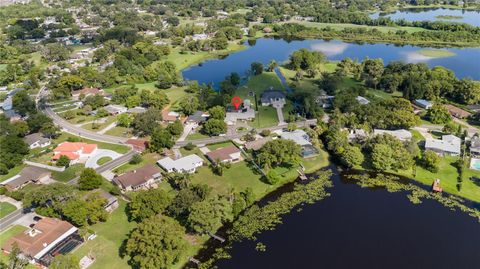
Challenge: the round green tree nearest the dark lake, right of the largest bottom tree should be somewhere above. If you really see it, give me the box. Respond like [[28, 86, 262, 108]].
[[188, 196, 229, 234]]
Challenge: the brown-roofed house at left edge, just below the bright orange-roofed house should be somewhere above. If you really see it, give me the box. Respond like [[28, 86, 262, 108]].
[[0, 166, 51, 191]]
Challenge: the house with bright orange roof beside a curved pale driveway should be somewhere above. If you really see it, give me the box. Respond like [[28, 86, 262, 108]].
[[52, 142, 97, 163]]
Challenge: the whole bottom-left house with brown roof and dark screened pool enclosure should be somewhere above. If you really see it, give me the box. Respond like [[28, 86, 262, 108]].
[[2, 217, 83, 267]]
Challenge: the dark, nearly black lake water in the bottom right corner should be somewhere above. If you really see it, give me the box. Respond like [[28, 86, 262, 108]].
[[217, 169, 480, 269]]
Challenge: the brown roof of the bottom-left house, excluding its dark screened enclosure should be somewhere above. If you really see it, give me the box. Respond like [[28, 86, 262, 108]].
[[2, 217, 74, 257]]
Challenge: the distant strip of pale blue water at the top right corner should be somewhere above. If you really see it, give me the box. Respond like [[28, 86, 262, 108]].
[[370, 8, 480, 26]]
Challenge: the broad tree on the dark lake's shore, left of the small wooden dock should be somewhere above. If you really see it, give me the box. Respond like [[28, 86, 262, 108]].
[[255, 139, 301, 168]]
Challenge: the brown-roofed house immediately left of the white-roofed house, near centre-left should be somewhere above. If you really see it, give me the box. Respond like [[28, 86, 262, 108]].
[[113, 164, 162, 191]]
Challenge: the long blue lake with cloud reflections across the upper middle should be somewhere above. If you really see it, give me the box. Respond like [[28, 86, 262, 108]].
[[182, 38, 480, 86]]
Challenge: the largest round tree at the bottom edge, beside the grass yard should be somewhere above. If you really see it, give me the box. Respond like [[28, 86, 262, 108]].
[[125, 215, 187, 269]]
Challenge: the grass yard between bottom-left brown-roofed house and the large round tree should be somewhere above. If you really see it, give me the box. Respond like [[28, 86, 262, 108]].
[[74, 200, 136, 269]]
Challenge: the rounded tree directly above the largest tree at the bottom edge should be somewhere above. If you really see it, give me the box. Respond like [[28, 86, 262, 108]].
[[128, 189, 172, 222]]
